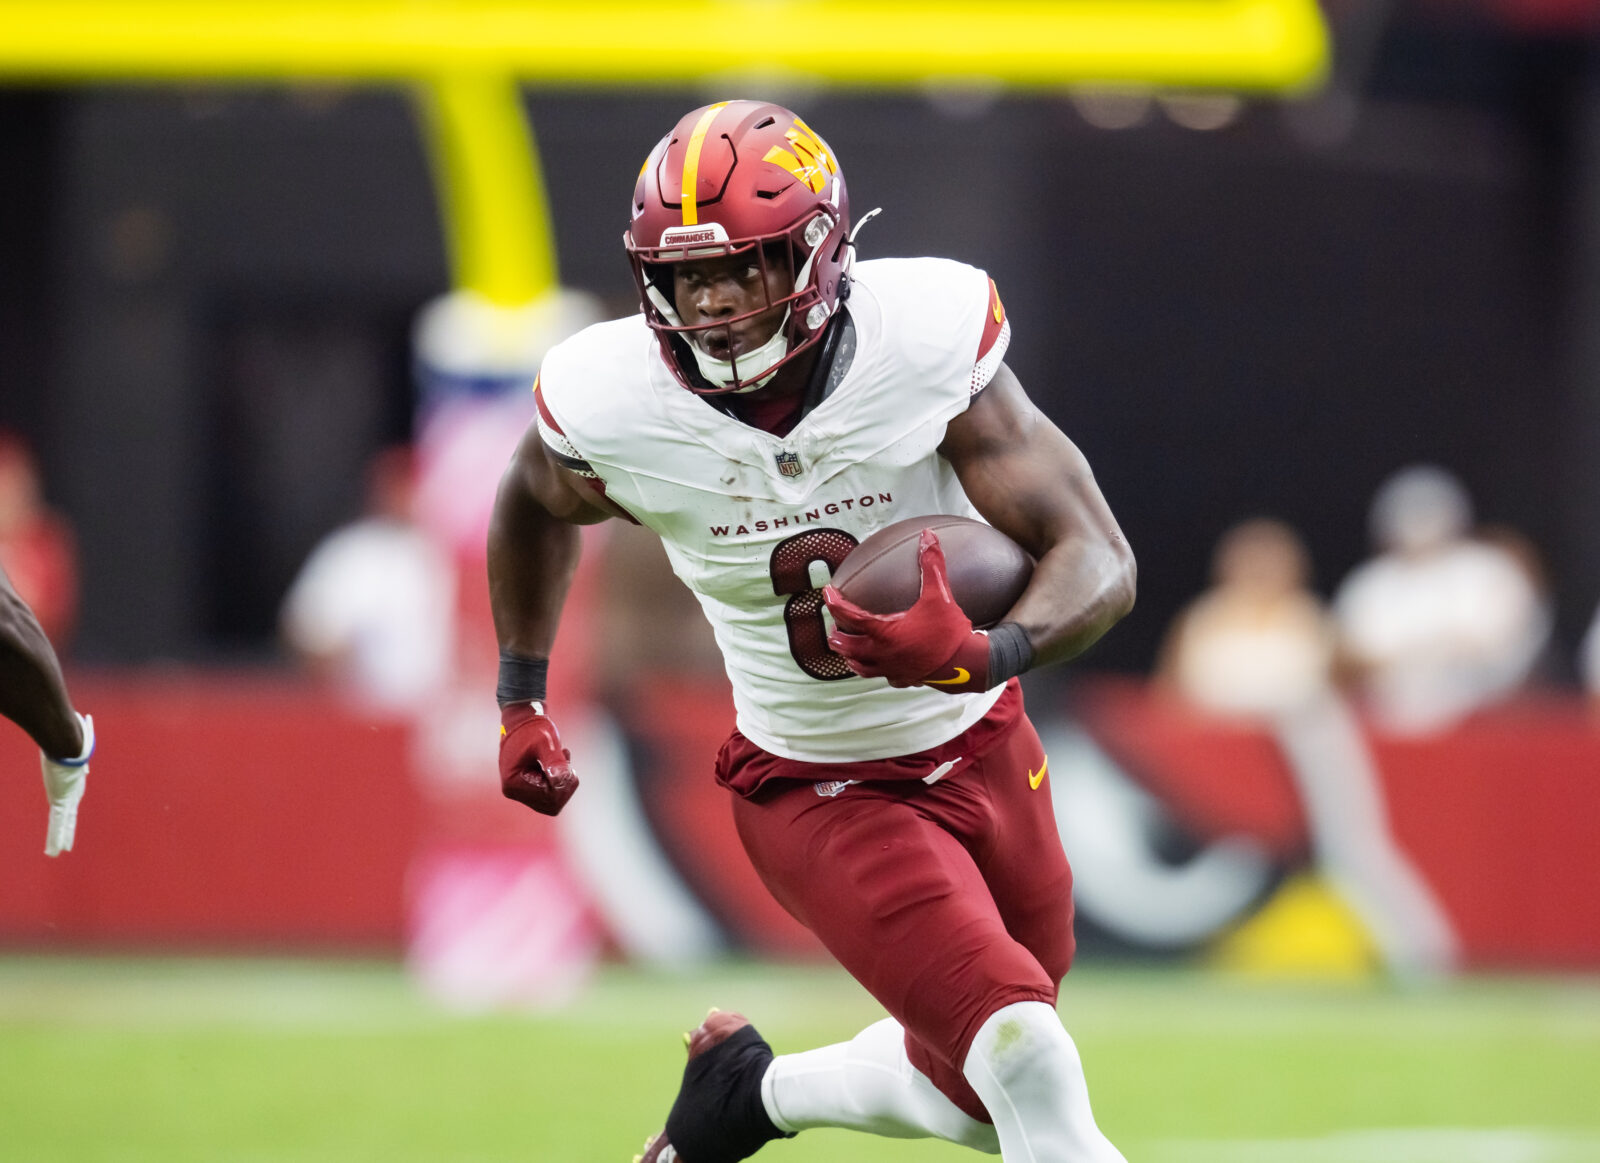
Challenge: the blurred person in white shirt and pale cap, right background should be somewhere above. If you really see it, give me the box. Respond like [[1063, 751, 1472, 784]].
[[1334, 466, 1550, 734]]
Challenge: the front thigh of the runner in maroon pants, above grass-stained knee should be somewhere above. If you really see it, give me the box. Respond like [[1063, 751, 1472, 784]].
[[734, 785, 1056, 1061]]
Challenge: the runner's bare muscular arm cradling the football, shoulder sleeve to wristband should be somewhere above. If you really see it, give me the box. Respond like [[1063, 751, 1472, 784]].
[[939, 363, 1136, 665]]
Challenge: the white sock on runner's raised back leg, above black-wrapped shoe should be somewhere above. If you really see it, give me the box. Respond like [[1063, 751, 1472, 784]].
[[762, 1017, 1000, 1155]]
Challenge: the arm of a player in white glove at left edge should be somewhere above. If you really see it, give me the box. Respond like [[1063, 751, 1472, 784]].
[[0, 570, 94, 856]]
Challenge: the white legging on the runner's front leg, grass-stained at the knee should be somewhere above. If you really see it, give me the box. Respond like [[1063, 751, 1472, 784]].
[[962, 1001, 1126, 1163]]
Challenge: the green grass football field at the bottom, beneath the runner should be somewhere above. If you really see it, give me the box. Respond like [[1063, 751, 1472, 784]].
[[0, 957, 1600, 1163]]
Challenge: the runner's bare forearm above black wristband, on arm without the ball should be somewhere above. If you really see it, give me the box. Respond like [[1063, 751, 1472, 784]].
[[488, 488, 592, 657]]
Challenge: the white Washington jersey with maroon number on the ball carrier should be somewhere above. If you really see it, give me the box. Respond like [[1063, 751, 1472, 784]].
[[539, 259, 1010, 763]]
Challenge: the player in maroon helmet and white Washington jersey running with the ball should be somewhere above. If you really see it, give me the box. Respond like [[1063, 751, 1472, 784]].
[[488, 101, 1134, 1163]]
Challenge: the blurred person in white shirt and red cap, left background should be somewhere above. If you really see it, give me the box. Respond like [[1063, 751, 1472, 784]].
[[280, 446, 456, 715]]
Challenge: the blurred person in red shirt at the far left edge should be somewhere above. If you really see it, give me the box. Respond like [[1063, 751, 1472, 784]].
[[0, 430, 78, 649]]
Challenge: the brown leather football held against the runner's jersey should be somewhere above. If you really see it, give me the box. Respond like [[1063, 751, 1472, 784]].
[[834, 515, 1034, 630]]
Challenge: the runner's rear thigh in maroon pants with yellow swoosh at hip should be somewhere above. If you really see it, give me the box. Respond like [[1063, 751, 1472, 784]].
[[976, 717, 1075, 982]]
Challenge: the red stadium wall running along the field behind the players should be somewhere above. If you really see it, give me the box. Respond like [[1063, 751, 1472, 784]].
[[0, 675, 1600, 968]]
